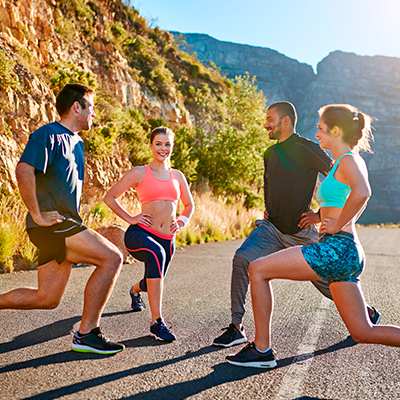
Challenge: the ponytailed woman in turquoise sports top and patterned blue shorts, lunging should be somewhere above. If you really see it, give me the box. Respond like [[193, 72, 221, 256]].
[[227, 104, 400, 368]]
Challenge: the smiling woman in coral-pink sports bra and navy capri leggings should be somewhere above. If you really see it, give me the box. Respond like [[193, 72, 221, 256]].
[[104, 127, 194, 342]]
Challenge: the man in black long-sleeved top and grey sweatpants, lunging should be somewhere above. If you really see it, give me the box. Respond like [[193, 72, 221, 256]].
[[213, 101, 380, 347]]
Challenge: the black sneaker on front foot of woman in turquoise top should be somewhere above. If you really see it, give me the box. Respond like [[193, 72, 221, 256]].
[[226, 343, 277, 369]]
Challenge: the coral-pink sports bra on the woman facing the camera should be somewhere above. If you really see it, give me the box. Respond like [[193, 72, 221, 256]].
[[136, 164, 181, 204]]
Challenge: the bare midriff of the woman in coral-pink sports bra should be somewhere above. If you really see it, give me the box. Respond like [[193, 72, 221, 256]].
[[142, 200, 176, 235]]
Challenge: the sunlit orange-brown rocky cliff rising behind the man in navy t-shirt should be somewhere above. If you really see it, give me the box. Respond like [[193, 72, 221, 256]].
[[0, 0, 185, 201]]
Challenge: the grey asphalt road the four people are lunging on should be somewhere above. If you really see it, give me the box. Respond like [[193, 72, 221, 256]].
[[0, 229, 400, 400]]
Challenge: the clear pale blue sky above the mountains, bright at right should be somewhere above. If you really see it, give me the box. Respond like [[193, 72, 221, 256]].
[[130, 0, 400, 69]]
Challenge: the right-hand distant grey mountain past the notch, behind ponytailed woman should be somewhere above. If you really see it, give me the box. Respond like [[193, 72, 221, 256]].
[[299, 51, 400, 223]]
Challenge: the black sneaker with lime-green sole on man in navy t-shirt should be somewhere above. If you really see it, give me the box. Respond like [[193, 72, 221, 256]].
[[71, 327, 125, 354]]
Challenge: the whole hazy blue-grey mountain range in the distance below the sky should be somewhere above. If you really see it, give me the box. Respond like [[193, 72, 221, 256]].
[[178, 34, 400, 224]]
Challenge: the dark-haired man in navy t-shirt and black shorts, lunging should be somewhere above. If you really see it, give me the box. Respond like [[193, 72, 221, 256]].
[[0, 84, 124, 354]]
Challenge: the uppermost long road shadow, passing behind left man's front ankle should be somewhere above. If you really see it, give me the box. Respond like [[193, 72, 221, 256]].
[[0, 311, 132, 354]]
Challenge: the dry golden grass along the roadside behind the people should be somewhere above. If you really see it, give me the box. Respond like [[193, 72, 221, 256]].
[[0, 192, 262, 273]]
